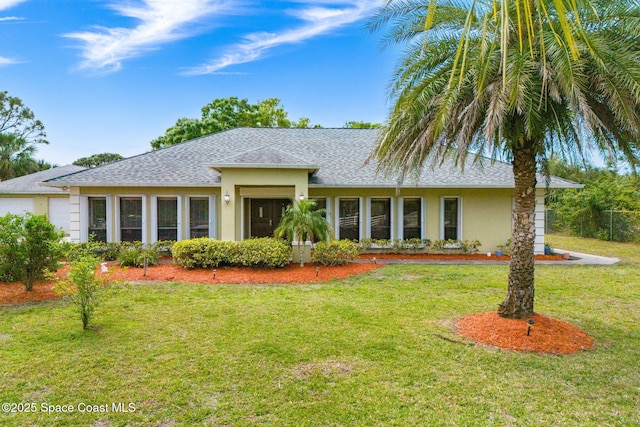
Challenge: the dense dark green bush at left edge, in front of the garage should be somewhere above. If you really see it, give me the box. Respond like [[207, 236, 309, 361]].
[[0, 214, 64, 291]]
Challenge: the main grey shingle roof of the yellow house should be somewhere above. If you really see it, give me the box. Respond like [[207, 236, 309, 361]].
[[42, 128, 579, 188]]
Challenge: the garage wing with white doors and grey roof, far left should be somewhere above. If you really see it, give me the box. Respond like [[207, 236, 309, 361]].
[[0, 165, 85, 233]]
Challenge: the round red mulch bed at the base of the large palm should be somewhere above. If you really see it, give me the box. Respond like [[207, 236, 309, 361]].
[[457, 312, 593, 354]]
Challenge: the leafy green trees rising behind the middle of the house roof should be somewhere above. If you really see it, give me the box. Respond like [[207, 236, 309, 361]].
[[151, 97, 316, 150]]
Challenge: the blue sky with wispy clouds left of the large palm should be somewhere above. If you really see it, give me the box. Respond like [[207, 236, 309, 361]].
[[0, 0, 397, 165]]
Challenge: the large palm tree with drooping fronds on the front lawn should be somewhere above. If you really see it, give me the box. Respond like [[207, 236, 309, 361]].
[[371, 0, 640, 318]]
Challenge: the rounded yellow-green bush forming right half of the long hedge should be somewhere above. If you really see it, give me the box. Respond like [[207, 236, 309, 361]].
[[237, 237, 291, 268]]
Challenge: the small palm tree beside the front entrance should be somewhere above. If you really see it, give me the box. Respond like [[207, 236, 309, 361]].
[[274, 199, 331, 267]]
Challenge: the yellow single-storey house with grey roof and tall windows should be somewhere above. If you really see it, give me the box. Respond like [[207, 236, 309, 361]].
[[41, 128, 579, 252]]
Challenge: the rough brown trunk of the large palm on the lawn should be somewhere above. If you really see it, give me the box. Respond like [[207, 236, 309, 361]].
[[498, 146, 536, 319]]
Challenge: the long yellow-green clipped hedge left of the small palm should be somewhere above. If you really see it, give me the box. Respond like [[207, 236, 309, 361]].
[[172, 237, 291, 269]]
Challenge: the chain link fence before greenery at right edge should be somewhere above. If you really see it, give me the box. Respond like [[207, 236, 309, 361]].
[[545, 209, 640, 243]]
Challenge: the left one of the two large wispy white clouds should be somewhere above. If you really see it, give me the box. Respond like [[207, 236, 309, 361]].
[[63, 0, 237, 72]]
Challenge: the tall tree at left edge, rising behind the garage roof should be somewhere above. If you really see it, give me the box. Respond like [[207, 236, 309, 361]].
[[0, 92, 50, 181]]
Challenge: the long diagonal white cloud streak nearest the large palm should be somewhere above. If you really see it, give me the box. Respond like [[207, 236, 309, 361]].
[[186, 0, 382, 75]]
